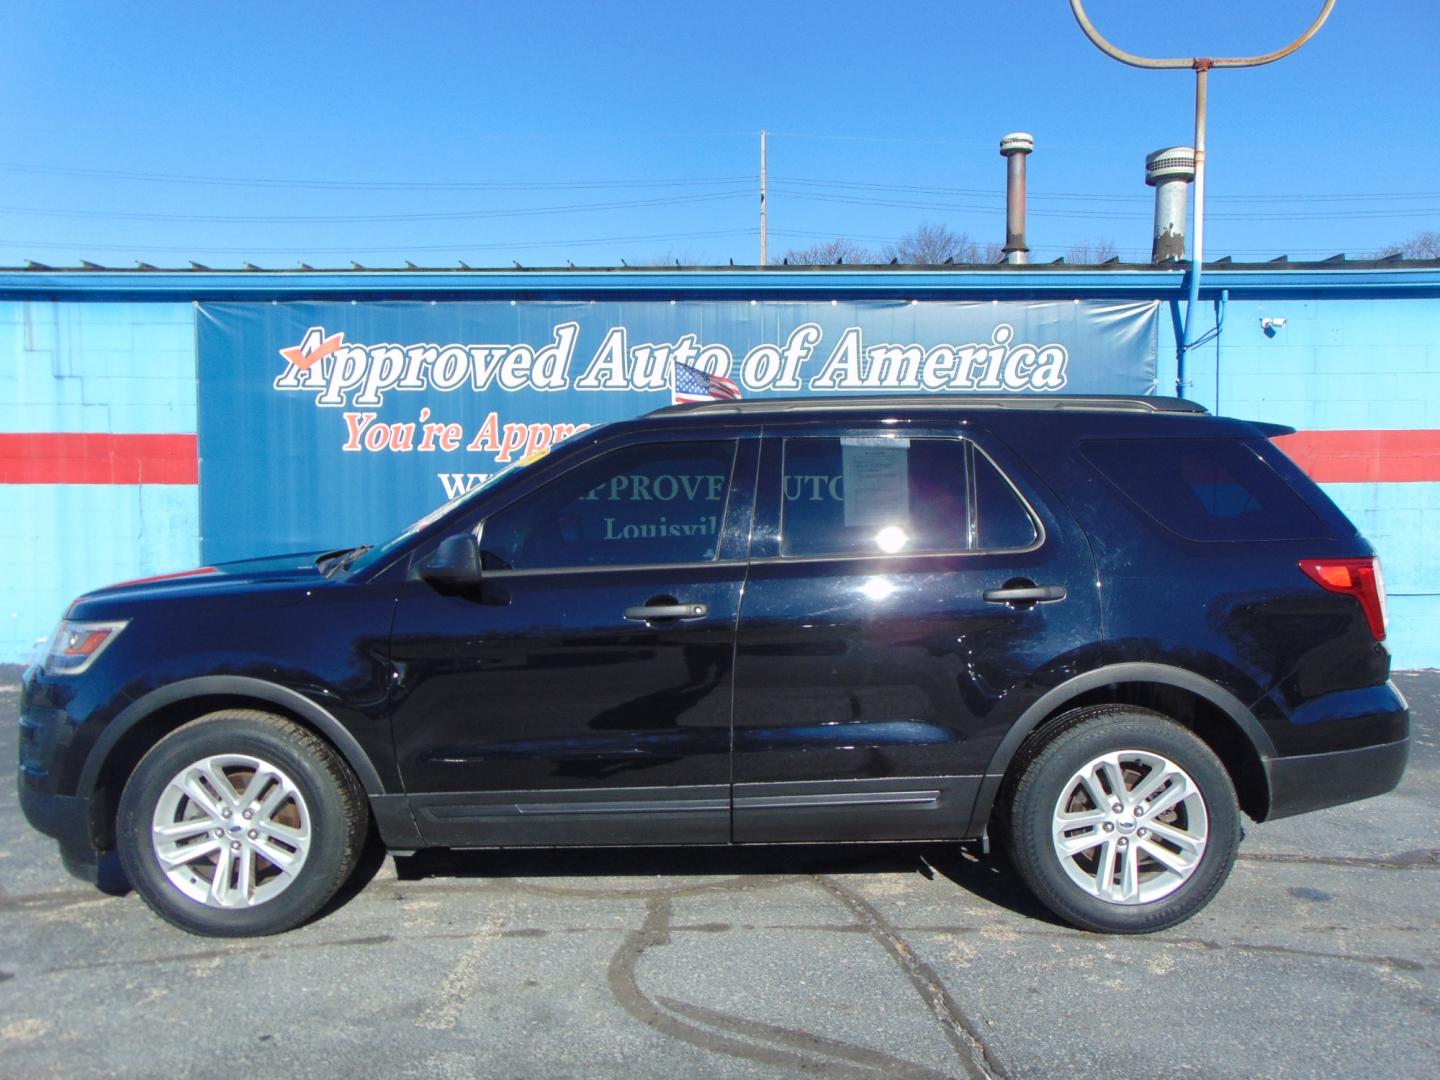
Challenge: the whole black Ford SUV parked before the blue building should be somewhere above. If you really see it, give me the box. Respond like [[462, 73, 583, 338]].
[[20, 396, 1410, 935]]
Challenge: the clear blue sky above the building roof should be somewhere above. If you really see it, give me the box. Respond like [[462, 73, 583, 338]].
[[0, 0, 1440, 266]]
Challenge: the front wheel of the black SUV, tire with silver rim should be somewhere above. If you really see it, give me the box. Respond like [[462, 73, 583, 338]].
[[115, 708, 369, 937]]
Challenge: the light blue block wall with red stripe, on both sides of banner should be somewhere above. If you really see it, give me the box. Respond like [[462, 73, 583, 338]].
[[0, 297, 1440, 667]]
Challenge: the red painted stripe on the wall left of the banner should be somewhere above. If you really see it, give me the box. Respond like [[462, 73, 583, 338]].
[[0, 432, 200, 484]]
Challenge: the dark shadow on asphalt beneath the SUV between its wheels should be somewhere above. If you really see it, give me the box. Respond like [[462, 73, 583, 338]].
[[383, 842, 1063, 926]]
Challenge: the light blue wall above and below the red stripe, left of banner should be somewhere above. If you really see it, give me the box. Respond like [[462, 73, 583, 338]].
[[0, 300, 200, 662]]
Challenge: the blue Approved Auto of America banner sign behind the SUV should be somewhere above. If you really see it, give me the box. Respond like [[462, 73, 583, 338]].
[[197, 300, 1159, 562]]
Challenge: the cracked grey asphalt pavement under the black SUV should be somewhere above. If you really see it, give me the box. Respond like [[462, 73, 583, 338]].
[[0, 670, 1440, 1080]]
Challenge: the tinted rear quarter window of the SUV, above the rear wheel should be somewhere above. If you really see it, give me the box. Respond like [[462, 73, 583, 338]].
[[1081, 439, 1331, 541]]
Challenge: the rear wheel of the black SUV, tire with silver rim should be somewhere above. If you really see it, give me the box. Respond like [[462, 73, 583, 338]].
[[1008, 706, 1240, 933]]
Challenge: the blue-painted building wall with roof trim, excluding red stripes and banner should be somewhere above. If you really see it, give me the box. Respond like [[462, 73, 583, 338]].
[[0, 268, 1440, 667]]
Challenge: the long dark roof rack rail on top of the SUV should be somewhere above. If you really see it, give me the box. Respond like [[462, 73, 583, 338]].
[[645, 393, 1210, 416]]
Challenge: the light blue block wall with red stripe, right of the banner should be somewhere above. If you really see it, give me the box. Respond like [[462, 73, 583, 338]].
[[1159, 297, 1440, 668]]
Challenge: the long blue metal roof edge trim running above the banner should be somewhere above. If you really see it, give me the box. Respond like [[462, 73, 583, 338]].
[[0, 258, 1440, 301]]
